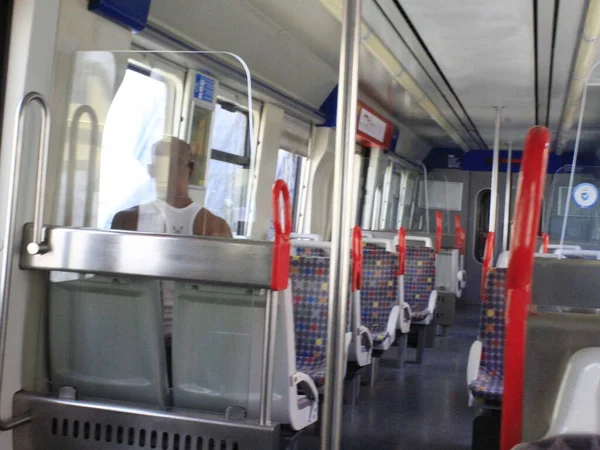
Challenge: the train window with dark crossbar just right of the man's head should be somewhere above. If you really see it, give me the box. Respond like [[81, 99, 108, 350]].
[[205, 102, 251, 235]]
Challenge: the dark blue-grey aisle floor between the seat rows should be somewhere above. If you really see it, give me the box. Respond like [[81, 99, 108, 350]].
[[299, 305, 479, 450]]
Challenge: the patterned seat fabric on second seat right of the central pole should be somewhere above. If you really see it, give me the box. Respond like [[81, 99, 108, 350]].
[[404, 247, 435, 323]]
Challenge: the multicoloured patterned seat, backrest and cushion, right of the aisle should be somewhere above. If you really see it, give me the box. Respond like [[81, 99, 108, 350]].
[[469, 268, 507, 407]]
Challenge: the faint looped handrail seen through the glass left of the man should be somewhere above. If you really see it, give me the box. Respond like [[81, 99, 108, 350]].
[[65, 105, 98, 227]]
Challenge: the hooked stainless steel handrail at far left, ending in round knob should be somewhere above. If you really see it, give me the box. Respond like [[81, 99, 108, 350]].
[[23, 92, 50, 255]]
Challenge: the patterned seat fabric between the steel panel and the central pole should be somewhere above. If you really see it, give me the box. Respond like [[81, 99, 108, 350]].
[[290, 256, 329, 386]]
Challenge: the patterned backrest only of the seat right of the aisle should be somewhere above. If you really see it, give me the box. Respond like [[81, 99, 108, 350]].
[[479, 268, 508, 376]]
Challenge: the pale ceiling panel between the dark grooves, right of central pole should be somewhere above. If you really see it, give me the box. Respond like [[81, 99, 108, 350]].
[[400, 0, 535, 147]]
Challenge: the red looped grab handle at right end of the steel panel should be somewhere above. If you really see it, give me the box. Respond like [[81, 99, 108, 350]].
[[271, 180, 292, 291]]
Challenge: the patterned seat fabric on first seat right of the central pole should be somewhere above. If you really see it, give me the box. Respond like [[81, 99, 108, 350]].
[[360, 248, 398, 348]]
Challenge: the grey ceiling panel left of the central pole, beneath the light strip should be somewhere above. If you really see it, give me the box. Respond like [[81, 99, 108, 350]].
[[150, 0, 340, 107]]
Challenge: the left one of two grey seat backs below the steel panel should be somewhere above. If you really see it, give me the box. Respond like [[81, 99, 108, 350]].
[[49, 277, 168, 406]]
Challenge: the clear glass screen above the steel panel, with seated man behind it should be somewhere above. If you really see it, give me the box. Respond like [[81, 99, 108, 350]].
[[51, 52, 254, 237]]
